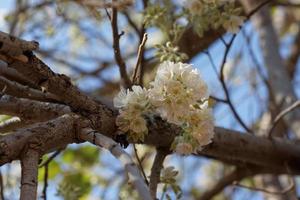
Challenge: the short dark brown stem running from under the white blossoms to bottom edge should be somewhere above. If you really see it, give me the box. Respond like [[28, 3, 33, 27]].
[[149, 148, 169, 199]]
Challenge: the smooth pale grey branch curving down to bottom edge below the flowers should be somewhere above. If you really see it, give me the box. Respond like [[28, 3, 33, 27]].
[[80, 128, 152, 200]]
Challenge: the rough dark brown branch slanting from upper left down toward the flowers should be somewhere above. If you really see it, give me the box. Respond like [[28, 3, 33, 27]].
[[9, 55, 116, 134]]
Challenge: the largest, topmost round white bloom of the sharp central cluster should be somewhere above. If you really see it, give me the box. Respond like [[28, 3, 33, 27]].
[[149, 62, 208, 125]]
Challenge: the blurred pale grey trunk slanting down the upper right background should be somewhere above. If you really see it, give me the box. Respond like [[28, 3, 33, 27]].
[[241, 0, 300, 136]]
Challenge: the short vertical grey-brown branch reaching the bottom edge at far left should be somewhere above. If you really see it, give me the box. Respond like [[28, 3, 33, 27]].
[[20, 148, 39, 200]]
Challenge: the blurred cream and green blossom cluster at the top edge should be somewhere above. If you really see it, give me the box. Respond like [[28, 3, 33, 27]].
[[186, 0, 245, 36]]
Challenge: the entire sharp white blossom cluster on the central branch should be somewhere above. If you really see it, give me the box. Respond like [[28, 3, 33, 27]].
[[114, 61, 214, 154]]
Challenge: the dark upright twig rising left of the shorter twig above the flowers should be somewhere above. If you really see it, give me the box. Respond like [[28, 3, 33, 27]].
[[111, 2, 131, 88]]
